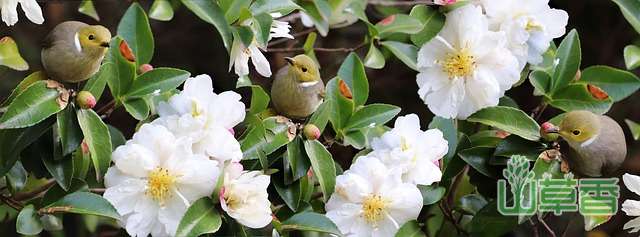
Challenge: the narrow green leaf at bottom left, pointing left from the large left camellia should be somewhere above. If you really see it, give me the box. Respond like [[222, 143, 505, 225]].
[[45, 192, 120, 220]]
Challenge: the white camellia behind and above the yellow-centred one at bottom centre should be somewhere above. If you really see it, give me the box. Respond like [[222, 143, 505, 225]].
[[371, 114, 449, 185]]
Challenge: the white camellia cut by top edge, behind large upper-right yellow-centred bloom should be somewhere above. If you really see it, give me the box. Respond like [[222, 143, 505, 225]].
[[479, 0, 569, 68]]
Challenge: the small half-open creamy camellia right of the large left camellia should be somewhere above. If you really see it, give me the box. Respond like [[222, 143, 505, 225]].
[[220, 163, 272, 228]]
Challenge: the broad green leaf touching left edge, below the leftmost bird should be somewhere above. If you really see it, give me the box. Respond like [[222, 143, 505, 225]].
[[0, 81, 68, 129]]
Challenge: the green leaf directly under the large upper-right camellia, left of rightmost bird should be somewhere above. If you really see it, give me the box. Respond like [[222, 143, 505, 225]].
[[467, 106, 540, 141]]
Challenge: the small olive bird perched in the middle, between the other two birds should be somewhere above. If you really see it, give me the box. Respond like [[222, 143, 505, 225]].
[[271, 54, 324, 119]]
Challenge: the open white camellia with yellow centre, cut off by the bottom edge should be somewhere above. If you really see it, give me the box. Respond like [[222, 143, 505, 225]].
[[325, 155, 422, 237]]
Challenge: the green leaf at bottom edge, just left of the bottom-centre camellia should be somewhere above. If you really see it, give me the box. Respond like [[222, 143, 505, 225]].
[[281, 212, 342, 236]]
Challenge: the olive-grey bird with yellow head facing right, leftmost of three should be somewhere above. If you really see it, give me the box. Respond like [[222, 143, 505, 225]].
[[41, 21, 111, 83]]
